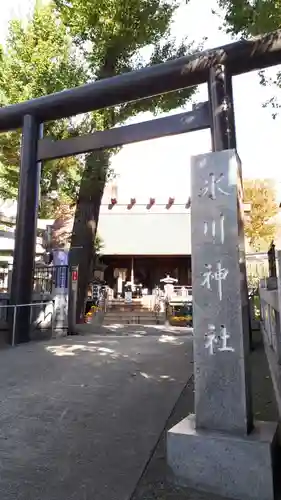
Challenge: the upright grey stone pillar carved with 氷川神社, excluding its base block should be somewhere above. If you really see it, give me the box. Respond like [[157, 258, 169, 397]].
[[191, 150, 252, 433]]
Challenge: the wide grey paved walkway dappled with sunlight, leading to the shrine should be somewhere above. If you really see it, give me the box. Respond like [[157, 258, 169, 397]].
[[0, 331, 193, 500]]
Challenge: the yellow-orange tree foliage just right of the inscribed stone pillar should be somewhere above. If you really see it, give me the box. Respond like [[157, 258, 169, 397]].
[[244, 179, 278, 251]]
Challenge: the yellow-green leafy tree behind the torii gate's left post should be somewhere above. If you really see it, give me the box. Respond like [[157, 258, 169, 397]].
[[0, 3, 87, 213]]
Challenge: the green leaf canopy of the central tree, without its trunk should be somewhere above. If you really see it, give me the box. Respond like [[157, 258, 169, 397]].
[[54, 0, 197, 124]]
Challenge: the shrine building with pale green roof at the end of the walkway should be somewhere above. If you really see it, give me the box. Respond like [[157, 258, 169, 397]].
[[98, 182, 191, 294]]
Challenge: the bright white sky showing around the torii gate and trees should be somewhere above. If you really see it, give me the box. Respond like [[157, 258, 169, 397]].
[[0, 0, 281, 201]]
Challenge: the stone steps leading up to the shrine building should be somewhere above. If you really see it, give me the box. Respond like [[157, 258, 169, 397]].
[[103, 299, 165, 326]]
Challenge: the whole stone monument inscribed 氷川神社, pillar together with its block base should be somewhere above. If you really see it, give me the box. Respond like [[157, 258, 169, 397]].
[[167, 150, 277, 500]]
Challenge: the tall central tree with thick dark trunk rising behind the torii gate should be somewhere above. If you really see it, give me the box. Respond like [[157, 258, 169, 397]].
[[55, 0, 196, 315]]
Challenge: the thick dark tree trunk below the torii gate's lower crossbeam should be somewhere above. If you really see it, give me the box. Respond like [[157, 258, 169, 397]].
[[71, 151, 107, 322]]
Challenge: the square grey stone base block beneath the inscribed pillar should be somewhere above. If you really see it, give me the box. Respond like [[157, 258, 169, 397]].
[[167, 415, 278, 500]]
